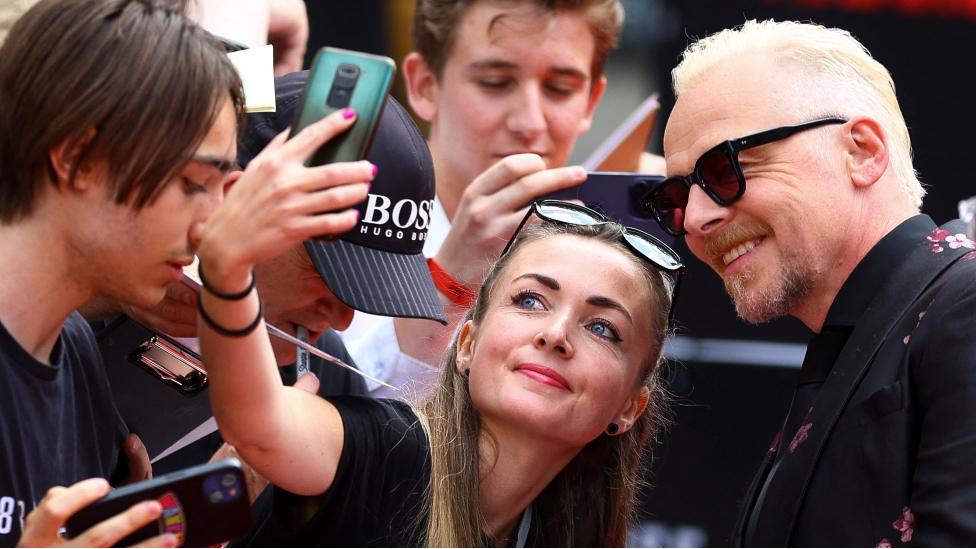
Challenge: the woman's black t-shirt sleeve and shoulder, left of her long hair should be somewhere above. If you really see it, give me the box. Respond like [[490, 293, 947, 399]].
[[241, 397, 430, 547]]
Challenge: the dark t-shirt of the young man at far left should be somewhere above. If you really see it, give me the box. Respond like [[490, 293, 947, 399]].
[[0, 313, 127, 547]]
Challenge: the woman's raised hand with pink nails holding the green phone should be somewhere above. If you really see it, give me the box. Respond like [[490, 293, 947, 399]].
[[199, 109, 376, 291]]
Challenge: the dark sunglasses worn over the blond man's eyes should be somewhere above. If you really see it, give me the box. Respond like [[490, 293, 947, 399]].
[[640, 116, 847, 236]]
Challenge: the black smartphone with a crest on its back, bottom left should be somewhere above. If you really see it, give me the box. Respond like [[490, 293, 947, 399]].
[[65, 459, 251, 547]]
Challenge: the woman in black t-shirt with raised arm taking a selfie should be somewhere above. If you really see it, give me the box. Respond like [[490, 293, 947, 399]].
[[200, 149, 682, 547]]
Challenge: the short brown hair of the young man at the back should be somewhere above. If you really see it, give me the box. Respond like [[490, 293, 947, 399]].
[[413, 0, 624, 81]]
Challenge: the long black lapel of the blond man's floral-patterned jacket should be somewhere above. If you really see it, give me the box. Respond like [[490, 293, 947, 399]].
[[753, 221, 971, 547]]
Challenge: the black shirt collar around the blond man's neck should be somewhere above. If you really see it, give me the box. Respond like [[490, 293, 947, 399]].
[[824, 214, 936, 328]]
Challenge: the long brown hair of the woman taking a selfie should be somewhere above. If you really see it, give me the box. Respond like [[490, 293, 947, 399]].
[[418, 223, 673, 547]]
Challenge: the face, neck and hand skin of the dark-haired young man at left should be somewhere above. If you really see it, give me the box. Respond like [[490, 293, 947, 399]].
[[0, 100, 237, 546]]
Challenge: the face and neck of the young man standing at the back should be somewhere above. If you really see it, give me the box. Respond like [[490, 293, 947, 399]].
[[406, 2, 606, 217]]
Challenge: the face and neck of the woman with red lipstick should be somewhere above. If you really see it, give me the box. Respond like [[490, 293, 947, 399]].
[[458, 235, 653, 540]]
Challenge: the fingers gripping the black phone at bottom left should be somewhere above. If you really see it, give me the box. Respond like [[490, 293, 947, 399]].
[[17, 478, 177, 547]]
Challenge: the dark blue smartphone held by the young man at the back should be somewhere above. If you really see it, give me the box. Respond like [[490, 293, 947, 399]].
[[536, 172, 674, 243]]
